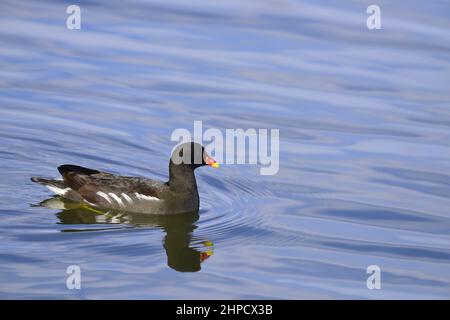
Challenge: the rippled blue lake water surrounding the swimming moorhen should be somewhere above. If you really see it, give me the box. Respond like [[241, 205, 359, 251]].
[[0, 0, 450, 299]]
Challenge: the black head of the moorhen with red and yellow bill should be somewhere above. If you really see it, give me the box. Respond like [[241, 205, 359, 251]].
[[170, 142, 219, 170]]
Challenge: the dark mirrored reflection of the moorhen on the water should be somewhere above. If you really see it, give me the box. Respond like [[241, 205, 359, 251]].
[[40, 197, 213, 272]]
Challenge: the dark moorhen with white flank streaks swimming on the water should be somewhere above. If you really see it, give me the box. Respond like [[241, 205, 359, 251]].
[[31, 142, 219, 214]]
